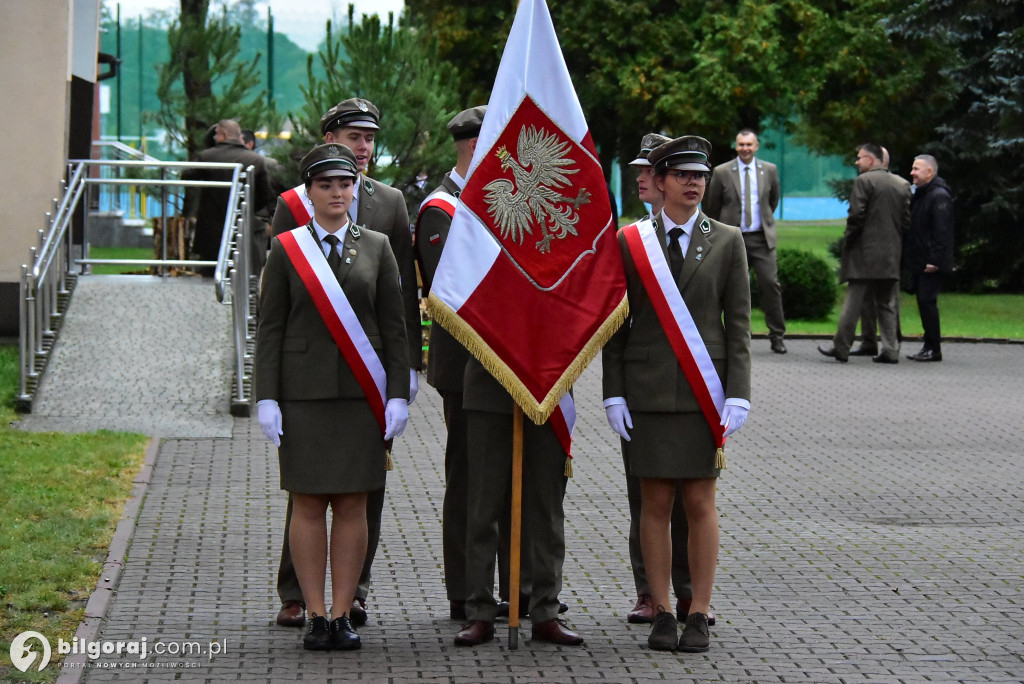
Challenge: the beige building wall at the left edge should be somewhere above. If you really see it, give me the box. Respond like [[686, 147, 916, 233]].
[[0, 0, 99, 337]]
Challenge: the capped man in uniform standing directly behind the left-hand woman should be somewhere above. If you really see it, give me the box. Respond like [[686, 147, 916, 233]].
[[271, 97, 423, 627]]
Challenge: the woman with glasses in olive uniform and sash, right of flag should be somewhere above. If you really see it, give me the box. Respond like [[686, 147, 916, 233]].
[[602, 135, 751, 651]]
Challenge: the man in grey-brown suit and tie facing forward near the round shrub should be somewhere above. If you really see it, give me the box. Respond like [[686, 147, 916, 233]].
[[702, 128, 785, 354]]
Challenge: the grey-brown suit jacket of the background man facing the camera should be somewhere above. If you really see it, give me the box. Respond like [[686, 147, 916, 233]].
[[700, 157, 779, 249]]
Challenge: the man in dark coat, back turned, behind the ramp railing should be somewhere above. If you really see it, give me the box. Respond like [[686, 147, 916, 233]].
[[181, 119, 272, 275]]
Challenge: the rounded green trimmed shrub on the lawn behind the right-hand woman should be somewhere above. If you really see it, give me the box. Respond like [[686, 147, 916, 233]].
[[751, 250, 839, 320]]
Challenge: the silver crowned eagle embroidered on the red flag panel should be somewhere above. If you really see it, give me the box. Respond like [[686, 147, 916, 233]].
[[483, 125, 590, 254]]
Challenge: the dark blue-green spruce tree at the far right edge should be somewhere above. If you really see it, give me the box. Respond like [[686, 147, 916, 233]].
[[890, 0, 1024, 292]]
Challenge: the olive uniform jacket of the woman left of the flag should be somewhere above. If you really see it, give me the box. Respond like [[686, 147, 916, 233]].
[[255, 224, 409, 401]]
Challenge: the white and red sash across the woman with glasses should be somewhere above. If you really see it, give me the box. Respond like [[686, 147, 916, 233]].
[[623, 219, 725, 448]]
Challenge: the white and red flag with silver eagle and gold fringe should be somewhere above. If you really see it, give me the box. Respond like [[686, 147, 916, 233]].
[[429, 0, 628, 428]]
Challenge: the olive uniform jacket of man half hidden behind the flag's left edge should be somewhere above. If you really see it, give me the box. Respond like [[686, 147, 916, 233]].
[[416, 173, 470, 392]]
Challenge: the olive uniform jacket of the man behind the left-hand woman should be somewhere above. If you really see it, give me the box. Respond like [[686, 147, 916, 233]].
[[271, 174, 423, 369]]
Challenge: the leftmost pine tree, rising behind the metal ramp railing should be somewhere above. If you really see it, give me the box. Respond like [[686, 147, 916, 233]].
[[154, 0, 281, 159]]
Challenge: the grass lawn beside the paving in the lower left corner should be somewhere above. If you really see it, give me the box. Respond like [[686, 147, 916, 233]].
[[0, 346, 147, 682]]
